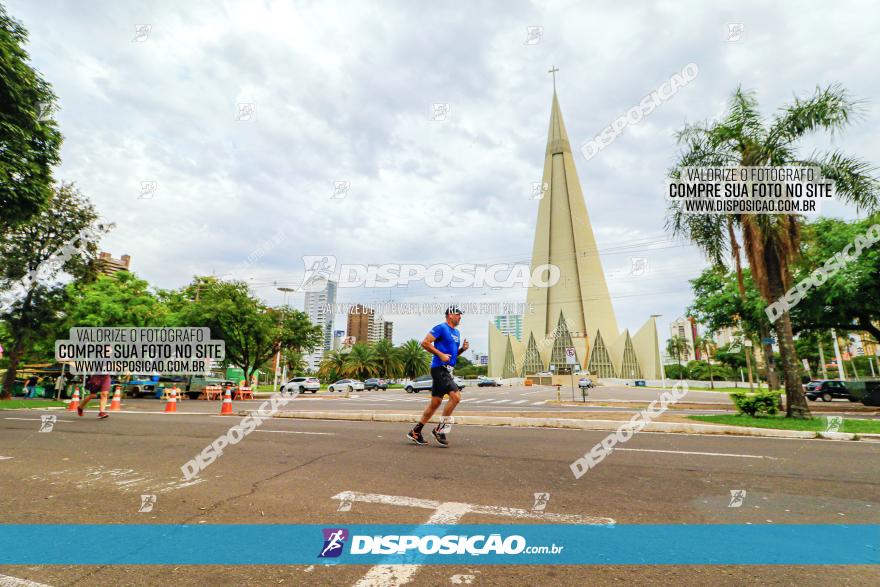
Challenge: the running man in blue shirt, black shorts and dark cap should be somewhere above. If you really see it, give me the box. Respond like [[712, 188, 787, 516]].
[[406, 306, 470, 446]]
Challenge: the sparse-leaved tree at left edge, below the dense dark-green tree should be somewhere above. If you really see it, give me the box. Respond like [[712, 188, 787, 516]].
[[0, 184, 107, 397]]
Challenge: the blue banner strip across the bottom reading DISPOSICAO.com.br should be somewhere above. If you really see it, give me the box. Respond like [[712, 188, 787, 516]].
[[0, 524, 880, 565]]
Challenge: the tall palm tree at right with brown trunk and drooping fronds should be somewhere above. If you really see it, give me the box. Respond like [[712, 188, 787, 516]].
[[667, 85, 880, 418]]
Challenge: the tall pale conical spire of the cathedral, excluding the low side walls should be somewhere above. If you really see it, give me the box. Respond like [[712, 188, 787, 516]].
[[523, 91, 619, 365]]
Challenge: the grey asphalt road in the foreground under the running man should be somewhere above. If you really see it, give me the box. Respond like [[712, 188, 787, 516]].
[[0, 406, 880, 586]]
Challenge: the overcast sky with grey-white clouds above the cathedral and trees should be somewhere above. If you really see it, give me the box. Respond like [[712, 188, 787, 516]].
[[6, 0, 880, 351]]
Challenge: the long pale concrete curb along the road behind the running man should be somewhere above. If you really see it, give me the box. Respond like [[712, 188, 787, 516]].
[[239, 410, 868, 440]]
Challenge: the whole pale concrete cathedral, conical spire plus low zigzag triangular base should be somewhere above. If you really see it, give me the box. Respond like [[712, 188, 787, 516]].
[[488, 89, 662, 380]]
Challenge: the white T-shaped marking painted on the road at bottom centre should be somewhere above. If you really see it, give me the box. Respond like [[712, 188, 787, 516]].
[[331, 491, 615, 587]]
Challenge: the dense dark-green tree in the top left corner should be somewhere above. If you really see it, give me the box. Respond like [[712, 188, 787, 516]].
[[0, 4, 62, 230]]
